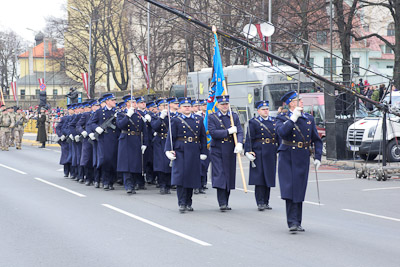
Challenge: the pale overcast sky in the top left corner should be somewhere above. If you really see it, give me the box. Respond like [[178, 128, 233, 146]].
[[0, 0, 67, 42]]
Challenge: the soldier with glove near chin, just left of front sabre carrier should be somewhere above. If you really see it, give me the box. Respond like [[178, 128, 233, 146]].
[[151, 99, 171, 195]]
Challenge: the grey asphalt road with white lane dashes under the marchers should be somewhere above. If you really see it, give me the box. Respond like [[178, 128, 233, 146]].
[[0, 146, 400, 267]]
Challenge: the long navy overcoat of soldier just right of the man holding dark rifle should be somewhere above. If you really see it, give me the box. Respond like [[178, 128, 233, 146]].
[[117, 111, 149, 173]]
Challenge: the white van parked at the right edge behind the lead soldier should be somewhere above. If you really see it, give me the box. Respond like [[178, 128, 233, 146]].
[[346, 91, 400, 161]]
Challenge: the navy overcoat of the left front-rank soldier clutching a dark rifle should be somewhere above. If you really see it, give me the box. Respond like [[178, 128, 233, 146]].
[[91, 106, 120, 171]]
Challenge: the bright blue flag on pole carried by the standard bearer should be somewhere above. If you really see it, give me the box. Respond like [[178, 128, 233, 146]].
[[204, 33, 227, 147]]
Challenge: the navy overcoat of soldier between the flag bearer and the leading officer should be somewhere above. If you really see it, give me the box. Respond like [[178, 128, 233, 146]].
[[244, 116, 278, 187]]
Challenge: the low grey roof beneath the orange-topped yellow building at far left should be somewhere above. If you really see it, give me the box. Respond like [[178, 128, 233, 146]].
[[17, 72, 82, 87]]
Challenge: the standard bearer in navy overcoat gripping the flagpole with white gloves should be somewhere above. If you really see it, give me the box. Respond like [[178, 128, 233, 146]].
[[208, 95, 243, 211]]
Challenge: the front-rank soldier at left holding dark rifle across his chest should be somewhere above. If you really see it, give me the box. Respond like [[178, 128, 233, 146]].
[[91, 93, 120, 191]]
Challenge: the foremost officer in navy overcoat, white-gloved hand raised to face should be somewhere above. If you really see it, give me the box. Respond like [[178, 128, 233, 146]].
[[276, 91, 322, 233]]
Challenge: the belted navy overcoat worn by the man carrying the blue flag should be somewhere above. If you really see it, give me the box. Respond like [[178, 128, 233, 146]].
[[208, 111, 243, 190]]
